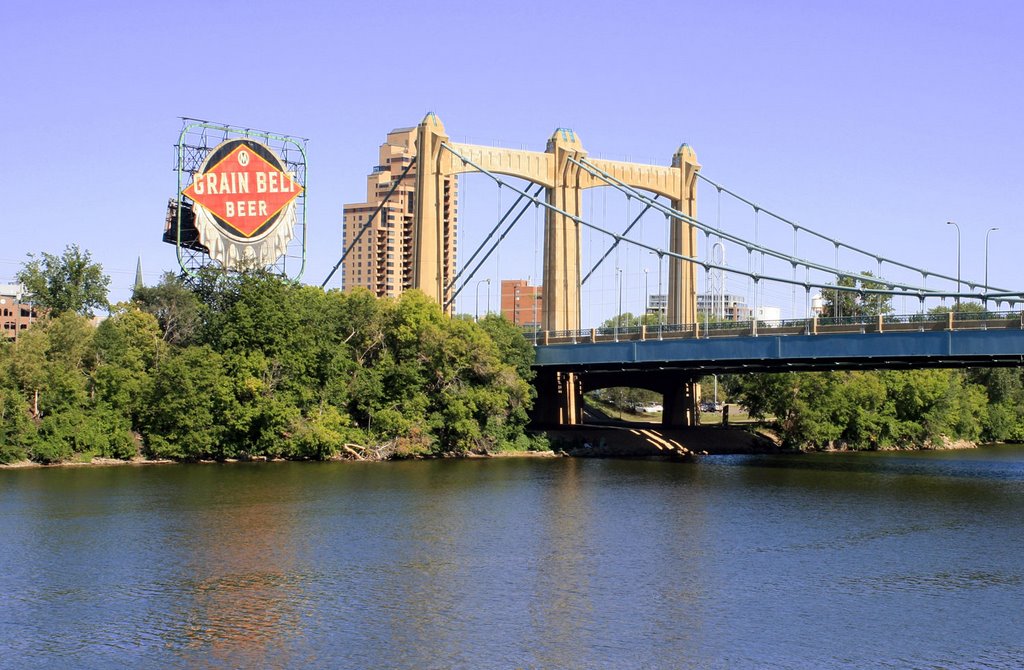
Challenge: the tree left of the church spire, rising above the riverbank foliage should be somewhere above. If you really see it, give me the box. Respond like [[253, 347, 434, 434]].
[[17, 244, 111, 317]]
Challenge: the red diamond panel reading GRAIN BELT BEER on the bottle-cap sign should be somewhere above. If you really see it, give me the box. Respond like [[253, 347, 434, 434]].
[[181, 139, 302, 239]]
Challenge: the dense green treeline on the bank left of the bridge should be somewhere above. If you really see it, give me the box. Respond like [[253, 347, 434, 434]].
[[0, 270, 538, 463]]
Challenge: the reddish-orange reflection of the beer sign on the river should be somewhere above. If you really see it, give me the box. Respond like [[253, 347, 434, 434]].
[[164, 475, 304, 667]]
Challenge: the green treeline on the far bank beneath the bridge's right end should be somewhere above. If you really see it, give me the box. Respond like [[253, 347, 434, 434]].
[[722, 368, 1024, 449]]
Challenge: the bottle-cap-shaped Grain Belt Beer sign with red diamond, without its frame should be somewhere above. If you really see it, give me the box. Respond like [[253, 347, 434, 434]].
[[181, 139, 302, 269]]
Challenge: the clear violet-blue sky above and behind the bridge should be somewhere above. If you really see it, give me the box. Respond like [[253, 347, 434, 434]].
[[0, 0, 1024, 325]]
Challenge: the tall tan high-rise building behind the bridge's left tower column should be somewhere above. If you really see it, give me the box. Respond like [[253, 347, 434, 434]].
[[341, 128, 458, 297]]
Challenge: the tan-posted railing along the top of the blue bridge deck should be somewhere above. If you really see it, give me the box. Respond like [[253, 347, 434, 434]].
[[524, 311, 1024, 345]]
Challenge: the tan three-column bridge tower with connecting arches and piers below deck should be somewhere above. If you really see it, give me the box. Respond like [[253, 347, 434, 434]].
[[412, 113, 700, 425]]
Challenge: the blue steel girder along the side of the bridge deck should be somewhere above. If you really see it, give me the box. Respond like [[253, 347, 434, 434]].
[[535, 322, 1024, 375]]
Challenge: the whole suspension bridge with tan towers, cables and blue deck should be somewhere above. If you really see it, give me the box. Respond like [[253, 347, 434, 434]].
[[324, 114, 1024, 426]]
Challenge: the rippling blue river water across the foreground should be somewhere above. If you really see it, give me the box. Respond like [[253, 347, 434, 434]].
[[0, 447, 1024, 668]]
